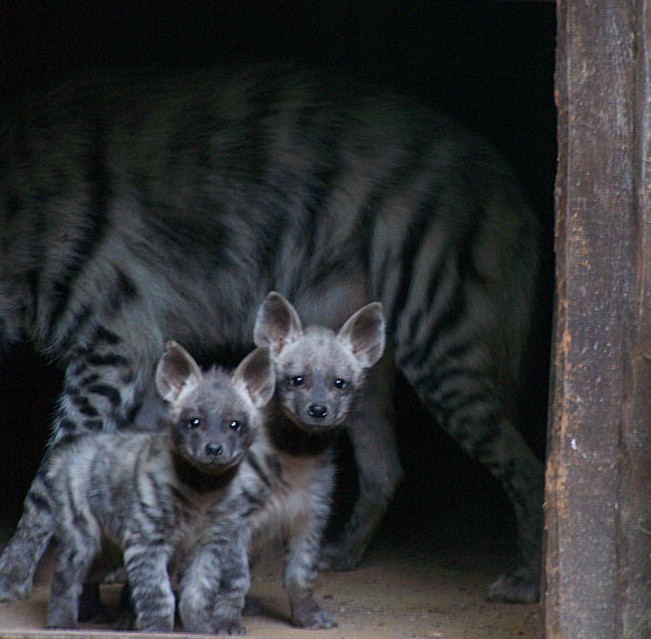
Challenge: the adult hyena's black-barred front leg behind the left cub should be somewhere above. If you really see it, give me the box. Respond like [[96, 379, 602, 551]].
[[0, 327, 162, 601]]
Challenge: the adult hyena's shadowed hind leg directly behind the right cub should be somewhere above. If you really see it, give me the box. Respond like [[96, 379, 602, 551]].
[[319, 353, 403, 570]]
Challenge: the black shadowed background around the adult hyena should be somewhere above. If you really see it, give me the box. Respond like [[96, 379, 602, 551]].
[[0, 0, 556, 556]]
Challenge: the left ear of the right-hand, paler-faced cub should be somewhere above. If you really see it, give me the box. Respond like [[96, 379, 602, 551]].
[[253, 291, 303, 355]]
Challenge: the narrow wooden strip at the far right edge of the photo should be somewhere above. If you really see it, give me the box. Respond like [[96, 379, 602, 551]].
[[619, 0, 651, 637]]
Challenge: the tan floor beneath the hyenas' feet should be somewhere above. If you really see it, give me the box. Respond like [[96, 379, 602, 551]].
[[0, 535, 542, 639]]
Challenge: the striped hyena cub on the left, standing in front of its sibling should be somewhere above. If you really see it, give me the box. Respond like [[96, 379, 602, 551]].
[[47, 342, 275, 634]]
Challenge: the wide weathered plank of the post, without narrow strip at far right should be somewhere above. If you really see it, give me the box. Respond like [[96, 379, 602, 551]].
[[544, 0, 641, 639]]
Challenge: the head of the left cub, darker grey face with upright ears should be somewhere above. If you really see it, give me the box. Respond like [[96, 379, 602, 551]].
[[156, 341, 275, 475]]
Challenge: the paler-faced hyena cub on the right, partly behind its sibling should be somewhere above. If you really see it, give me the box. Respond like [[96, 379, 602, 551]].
[[251, 292, 385, 628]]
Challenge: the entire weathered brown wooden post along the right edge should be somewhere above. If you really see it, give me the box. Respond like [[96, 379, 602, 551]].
[[544, 0, 651, 639]]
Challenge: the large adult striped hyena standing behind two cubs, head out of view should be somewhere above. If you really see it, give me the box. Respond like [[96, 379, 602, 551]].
[[0, 66, 543, 601]]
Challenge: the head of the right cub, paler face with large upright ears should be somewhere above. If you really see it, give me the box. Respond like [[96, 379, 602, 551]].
[[254, 292, 385, 431]]
